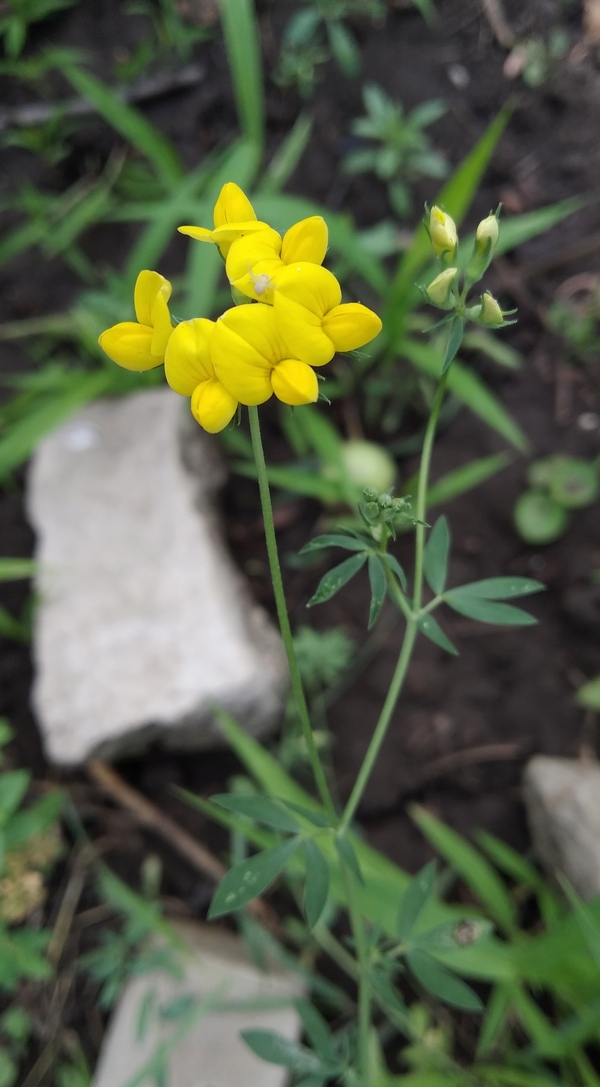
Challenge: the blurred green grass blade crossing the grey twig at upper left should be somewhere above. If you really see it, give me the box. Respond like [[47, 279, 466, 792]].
[[62, 64, 183, 187]]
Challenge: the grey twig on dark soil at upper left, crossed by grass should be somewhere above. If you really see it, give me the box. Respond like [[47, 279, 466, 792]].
[[0, 64, 204, 132]]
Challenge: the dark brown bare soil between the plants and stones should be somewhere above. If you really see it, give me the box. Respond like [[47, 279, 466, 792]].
[[0, 0, 600, 1069]]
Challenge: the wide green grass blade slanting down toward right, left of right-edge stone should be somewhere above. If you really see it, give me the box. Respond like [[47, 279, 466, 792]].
[[409, 804, 516, 932]]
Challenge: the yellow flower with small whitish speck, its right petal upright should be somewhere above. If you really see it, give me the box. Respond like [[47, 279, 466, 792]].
[[225, 215, 328, 303]]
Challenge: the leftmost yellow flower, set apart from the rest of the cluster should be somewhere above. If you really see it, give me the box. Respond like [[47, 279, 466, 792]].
[[98, 271, 173, 371]]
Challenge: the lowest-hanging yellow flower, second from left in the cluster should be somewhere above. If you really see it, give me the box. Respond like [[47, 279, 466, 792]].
[[164, 317, 237, 434]]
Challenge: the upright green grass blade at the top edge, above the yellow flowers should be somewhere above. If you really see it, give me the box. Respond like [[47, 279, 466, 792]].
[[218, 0, 264, 150]]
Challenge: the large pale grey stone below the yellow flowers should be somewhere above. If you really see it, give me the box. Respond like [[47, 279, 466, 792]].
[[27, 389, 287, 764]]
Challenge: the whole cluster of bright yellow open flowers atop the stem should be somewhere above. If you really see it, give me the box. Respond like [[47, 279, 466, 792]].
[[99, 182, 382, 434]]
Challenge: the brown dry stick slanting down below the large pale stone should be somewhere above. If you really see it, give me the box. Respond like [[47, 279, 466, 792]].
[[86, 759, 279, 933]]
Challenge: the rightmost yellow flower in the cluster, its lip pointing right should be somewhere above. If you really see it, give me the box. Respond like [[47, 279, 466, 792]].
[[273, 262, 382, 366]]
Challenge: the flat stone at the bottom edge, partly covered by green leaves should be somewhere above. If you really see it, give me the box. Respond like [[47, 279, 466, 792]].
[[93, 923, 302, 1087]]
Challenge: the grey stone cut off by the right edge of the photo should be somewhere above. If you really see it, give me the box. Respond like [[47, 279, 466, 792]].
[[523, 754, 600, 899]]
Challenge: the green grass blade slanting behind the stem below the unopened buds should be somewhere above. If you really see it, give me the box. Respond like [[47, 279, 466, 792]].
[[401, 339, 529, 453]]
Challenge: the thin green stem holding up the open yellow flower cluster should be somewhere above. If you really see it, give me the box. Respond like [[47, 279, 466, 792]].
[[248, 408, 336, 822]]
